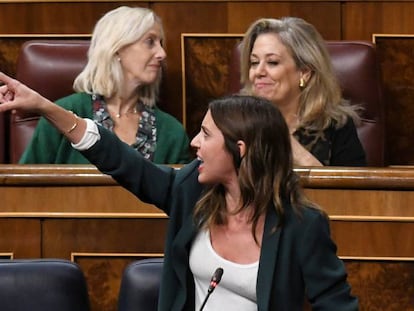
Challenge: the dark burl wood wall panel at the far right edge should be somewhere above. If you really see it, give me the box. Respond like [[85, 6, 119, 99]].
[[374, 34, 414, 165]]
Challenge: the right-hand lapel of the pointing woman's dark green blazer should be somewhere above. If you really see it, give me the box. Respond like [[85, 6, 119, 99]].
[[256, 208, 281, 311]]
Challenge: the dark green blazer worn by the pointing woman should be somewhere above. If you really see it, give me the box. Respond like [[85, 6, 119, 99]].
[[83, 127, 358, 311]]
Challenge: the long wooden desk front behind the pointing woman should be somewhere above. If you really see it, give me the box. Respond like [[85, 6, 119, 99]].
[[0, 165, 414, 311]]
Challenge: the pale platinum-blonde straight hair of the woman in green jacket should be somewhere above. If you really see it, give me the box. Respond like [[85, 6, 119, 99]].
[[73, 6, 164, 107]]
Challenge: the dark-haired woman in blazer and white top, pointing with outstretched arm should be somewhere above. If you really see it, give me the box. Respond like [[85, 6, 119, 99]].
[[0, 74, 358, 311]]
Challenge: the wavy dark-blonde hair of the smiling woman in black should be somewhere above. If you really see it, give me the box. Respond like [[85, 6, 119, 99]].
[[240, 17, 360, 131]]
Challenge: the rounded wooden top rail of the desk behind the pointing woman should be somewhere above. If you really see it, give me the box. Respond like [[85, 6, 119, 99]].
[[0, 164, 414, 190]]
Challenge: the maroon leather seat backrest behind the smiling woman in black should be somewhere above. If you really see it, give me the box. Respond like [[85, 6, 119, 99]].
[[229, 41, 386, 166]]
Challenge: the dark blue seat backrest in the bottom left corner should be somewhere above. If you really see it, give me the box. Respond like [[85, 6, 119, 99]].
[[0, 259, 90, 311]]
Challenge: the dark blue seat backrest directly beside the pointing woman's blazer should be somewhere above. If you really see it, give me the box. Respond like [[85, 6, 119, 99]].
[[118, 258, 164, 311]]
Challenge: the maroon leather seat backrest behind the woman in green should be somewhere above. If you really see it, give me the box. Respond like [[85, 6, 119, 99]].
[[9, 39, 90, 163]]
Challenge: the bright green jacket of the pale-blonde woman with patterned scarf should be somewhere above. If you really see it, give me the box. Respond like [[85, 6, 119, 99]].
[[19, 93, 190, 164]]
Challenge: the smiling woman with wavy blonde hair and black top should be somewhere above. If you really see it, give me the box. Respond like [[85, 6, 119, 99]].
[[241, 17, 366, 166]]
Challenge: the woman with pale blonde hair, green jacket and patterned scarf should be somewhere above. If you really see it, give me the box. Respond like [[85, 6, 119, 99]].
[[20, 6, 190, 164]]
